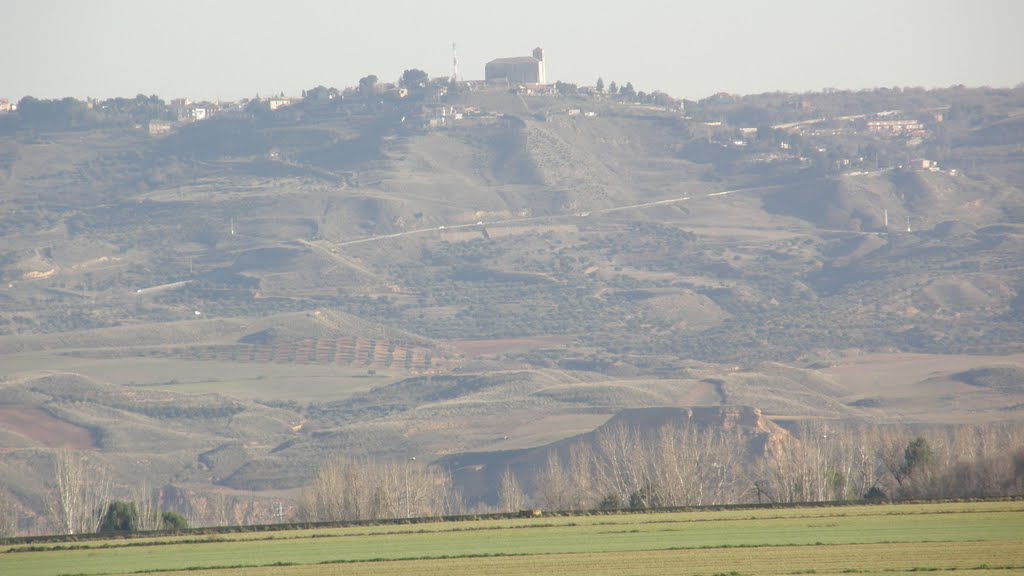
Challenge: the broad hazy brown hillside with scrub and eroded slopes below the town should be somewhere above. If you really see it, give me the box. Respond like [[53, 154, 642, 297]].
[[0, 84, 1024, 529]]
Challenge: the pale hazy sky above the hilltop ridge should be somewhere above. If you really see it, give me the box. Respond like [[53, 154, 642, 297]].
[[0, 0, 1024, 99]]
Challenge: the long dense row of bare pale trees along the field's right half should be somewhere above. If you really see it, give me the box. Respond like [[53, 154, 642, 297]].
[[512, 414, 1024, 510]]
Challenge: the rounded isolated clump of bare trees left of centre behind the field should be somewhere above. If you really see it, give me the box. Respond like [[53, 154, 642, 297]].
[[296, 457, 461, 522]]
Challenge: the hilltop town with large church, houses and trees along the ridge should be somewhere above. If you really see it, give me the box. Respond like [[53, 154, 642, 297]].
[[0, 48, 976, 181]]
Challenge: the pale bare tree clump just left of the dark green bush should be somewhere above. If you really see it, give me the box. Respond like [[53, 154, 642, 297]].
[[46, 450, 111, 534]]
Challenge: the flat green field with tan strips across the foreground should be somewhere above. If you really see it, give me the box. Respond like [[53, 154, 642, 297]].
[[0, 501, 1024, 576]]
